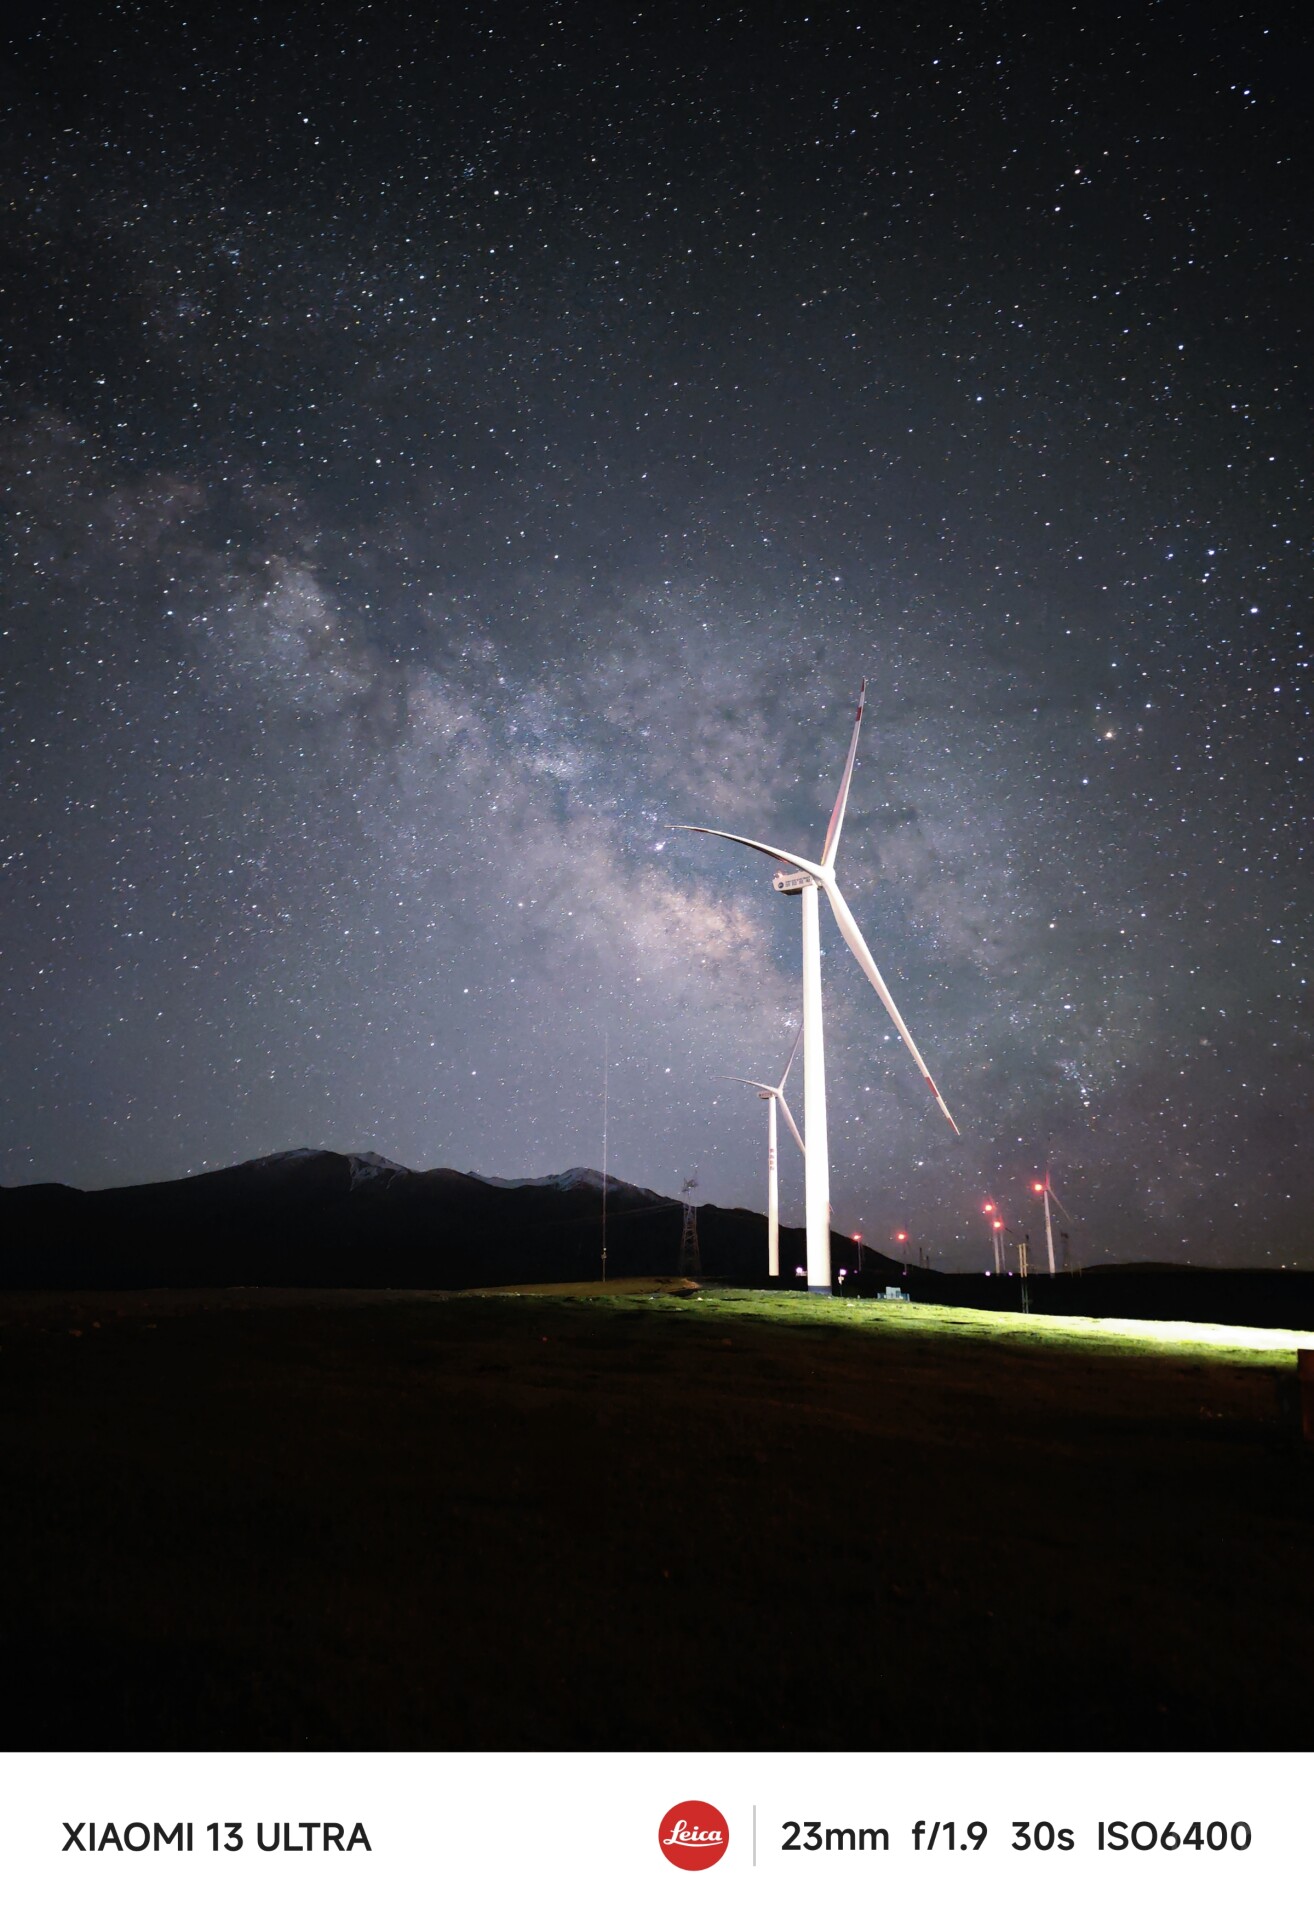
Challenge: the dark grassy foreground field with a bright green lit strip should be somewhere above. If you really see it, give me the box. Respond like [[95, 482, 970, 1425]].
[[0, 1292, 1314, 1749]]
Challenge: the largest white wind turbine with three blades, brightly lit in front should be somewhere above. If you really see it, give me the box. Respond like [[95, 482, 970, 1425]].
[[674, 682, 959, 1292]]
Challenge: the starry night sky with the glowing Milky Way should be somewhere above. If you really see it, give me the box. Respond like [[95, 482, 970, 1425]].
[[0, 0, 1314, 1265]]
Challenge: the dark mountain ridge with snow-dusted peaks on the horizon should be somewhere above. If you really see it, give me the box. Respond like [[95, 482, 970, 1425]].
[[0, 1146, 899, 1288]]
